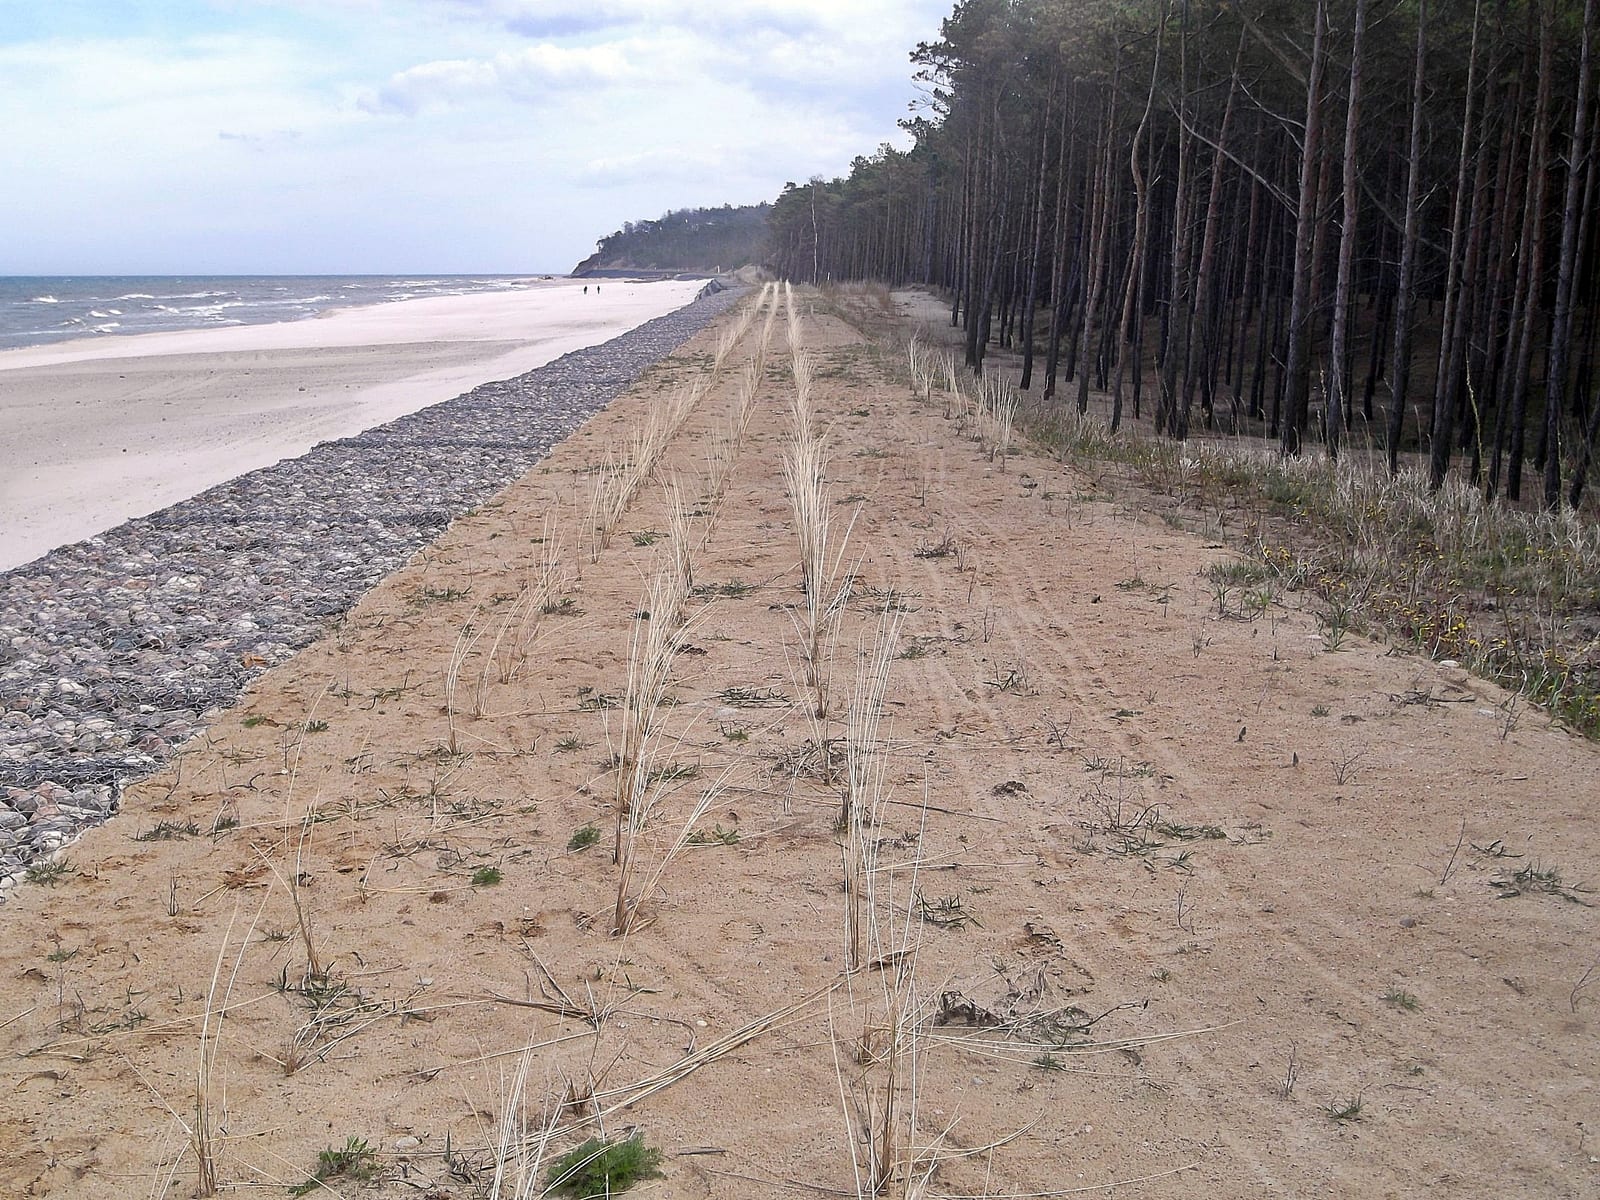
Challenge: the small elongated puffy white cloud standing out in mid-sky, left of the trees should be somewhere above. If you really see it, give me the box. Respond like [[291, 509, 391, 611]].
[[358, 43, 634, 117]]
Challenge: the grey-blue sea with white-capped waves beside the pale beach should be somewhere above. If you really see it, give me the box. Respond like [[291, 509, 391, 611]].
[[0, 275, 560, 350]]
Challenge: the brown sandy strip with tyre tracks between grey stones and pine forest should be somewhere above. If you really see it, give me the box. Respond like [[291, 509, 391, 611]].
[[0, 291, 1600, 1200]]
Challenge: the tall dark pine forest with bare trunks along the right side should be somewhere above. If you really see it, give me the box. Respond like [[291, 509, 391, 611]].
[[770, 0, 1600, 509]]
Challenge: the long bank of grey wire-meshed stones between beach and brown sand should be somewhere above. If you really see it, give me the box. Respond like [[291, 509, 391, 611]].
[[0, 290, 742, 896]]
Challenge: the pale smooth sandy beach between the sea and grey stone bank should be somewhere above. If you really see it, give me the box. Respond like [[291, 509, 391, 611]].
[[0, 280, 702, 570]]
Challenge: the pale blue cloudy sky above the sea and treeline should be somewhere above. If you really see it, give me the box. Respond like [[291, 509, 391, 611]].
[[0, 0, 952, 275]]
